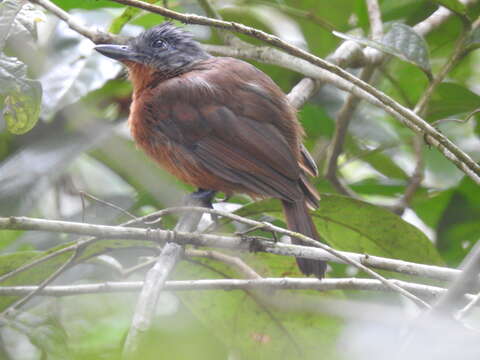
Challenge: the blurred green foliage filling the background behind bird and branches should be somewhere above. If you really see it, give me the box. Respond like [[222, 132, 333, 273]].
[[0, 0, 480, 359]]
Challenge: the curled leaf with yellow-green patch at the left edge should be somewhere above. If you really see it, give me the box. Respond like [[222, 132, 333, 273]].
[[0, 54, 42, 134]]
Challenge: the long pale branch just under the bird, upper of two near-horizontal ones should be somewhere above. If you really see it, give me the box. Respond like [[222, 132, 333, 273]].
[[0, 214, 460, 280]]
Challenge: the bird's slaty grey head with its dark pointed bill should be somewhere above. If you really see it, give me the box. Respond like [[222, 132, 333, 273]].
[[95, 22, 210, 74]]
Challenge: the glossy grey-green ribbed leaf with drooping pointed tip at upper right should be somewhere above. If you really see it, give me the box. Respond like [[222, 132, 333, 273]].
[[334, 23, 432, 78]]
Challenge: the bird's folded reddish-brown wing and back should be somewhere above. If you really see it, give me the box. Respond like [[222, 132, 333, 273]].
[[135, 58, 314, 201]]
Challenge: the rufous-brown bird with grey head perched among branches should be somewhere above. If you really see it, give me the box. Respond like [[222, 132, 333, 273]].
[[95, 22, 326, 279]]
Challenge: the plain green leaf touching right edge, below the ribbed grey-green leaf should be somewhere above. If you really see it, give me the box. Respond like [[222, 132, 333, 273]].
[[427, 82, 480, 121]]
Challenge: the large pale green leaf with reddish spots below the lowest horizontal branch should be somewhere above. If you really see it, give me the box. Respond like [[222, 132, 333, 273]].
[[175, 254, 341, 359]]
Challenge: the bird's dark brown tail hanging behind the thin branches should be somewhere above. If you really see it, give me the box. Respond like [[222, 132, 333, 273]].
[[282, 200, 327, 279]]
